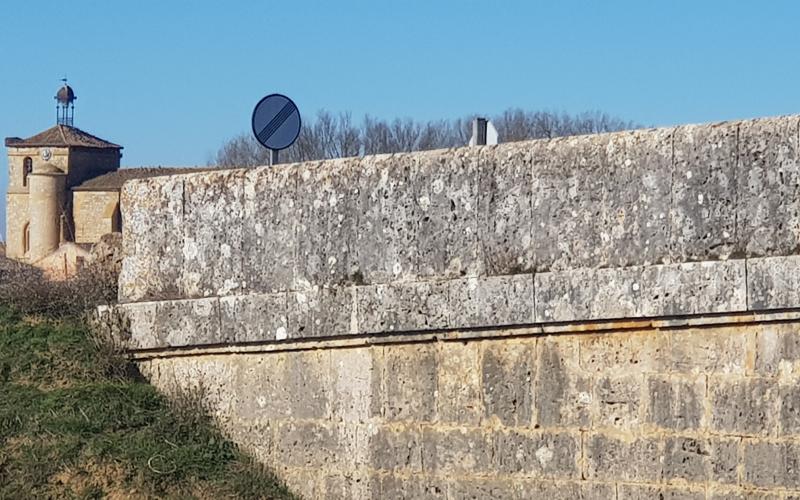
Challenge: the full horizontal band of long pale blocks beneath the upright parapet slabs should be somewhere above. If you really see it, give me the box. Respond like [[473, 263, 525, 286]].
[[103, 256, 800, 350]]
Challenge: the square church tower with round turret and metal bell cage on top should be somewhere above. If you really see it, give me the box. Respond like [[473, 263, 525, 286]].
[[5, 81, 122, 264]]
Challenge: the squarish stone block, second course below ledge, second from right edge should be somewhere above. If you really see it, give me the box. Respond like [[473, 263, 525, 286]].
[[708, 378, 779, 435]]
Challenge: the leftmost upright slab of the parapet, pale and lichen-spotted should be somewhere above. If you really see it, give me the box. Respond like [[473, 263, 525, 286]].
[[119, 177, 184, 303]]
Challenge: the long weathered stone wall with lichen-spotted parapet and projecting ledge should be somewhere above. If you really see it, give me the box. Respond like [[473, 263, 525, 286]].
[[117, 117, 800, 498]]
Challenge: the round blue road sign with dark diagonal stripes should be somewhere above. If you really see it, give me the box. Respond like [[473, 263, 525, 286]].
[[252, 94, 300, 151]]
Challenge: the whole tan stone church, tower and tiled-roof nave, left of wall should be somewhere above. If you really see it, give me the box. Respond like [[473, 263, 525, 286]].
[[5, 82, 200, 276]]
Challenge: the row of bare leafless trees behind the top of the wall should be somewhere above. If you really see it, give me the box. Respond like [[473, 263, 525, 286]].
[[209, 109, 639, 167]]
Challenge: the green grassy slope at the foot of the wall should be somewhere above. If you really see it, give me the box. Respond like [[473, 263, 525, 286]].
[[0, 306, 291, 498]]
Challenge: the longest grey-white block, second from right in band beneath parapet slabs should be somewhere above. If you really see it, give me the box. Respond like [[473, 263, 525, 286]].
[[534, 261, 747, 323]]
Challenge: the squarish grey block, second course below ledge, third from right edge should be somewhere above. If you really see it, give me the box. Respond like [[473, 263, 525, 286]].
[[645, 375, 706, 431]]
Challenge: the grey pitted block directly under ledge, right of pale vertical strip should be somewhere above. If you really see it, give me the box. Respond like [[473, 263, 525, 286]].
[[383, 344, 438, 423]]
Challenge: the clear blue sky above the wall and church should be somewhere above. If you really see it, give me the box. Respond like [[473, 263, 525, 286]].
[[0, 0, 800, 240]]
